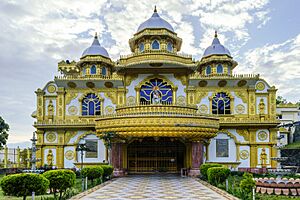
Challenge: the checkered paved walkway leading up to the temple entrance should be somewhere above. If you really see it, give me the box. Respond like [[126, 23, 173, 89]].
[[81, 175, 226, 200]]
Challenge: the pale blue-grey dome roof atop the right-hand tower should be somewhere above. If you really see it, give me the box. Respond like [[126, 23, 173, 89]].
[[203, 32, 231, 57]]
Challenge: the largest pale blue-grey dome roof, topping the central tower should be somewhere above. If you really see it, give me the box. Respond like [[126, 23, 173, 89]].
[[137, 7, 174, 32]]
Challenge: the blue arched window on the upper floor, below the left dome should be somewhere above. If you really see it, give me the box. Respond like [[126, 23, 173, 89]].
[[82, 93, 101, 116]]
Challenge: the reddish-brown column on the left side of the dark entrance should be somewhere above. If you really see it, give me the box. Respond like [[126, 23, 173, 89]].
[[111, 143, 124, 176]]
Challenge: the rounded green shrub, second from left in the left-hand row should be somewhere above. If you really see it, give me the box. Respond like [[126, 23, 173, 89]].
[[43, 169, 76, 199]]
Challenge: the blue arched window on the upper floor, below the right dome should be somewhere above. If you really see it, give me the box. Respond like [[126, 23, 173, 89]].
[[212, 92, 230, 115]]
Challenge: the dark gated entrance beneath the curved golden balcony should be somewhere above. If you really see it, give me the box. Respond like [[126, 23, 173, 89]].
[[127, 137, 186, 173]]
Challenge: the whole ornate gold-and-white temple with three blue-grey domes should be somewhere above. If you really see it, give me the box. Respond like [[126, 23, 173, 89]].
[[33, 9, 278, 175]]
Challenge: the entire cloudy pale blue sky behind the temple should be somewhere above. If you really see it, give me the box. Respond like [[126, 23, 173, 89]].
[[0, 0, 300, 147]]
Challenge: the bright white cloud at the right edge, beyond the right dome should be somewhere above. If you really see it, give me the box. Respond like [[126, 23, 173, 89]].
[[238, 34, 300, 102]]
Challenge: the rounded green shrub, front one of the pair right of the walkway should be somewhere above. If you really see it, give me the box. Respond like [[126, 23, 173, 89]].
[[207, 167, 230, 186]]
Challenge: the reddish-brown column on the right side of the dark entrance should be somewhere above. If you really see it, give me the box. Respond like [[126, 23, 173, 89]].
[[189, 142, 203, 176]]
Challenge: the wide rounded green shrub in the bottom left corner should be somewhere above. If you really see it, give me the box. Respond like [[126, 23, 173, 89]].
[[0, 173, 49, 199]]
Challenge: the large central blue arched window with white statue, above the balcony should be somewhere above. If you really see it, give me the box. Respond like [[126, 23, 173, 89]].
[[140, 78, 173, 104]]
